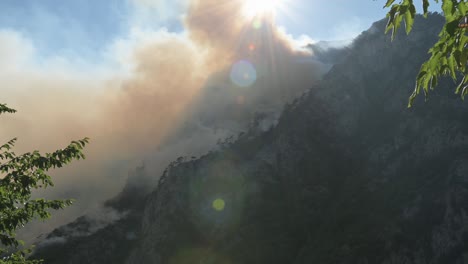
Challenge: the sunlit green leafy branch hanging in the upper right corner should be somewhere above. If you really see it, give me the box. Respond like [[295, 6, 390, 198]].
[[384, 0, 468, 107]]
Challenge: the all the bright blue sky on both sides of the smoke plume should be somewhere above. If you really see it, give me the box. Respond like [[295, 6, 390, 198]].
[[0, 0, 438, 60]]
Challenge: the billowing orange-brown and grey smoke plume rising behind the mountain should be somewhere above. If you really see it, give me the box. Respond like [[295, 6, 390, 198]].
[[0, 0, 326, 239]]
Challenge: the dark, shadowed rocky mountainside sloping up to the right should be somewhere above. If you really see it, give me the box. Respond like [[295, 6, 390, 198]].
[[37, 15, 468, 264]]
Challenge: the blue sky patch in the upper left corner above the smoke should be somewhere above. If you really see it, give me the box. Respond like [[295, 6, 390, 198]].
[[0, 0, 128, 59]]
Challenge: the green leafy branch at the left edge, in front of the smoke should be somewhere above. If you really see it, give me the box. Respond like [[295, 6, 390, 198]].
[[0, 104, 89, 264]]
